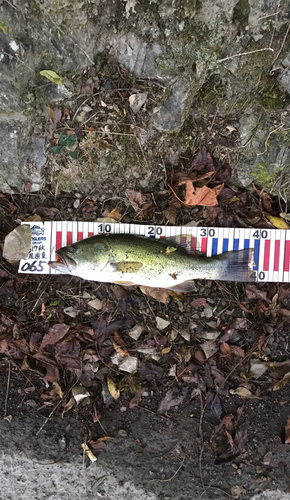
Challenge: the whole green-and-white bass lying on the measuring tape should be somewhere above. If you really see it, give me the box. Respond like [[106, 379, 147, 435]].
[[49, 234, 257, 292]]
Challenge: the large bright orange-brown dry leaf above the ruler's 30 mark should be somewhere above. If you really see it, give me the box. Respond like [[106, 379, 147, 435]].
[[174, 180, 224, 207]]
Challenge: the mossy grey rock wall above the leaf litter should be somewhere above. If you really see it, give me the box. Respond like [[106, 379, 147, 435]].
[[0, 0, 290, 196]]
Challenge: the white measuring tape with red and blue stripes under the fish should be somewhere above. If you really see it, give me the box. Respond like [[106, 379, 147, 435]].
[[19, 221, 290, 283]]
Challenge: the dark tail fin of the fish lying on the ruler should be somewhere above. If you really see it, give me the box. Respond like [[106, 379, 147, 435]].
[[218, 248, 257, 281]]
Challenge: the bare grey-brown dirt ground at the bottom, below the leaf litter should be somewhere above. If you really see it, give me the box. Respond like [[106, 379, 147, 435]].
[[0, 366, 290, 500]]
